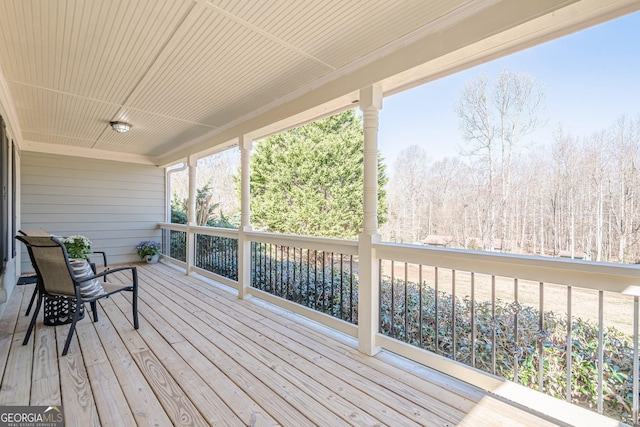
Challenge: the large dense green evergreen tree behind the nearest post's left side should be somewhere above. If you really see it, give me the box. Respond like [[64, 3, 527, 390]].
[[251, 110, 387, 238]]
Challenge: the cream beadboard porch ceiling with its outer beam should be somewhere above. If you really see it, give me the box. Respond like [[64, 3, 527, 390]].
[[0, 0, 640, 164]]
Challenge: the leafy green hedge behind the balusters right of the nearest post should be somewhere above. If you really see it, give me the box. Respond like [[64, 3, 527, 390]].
[[380, 280, 633, 424]]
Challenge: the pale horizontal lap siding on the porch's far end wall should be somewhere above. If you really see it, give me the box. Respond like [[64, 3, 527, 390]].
[[20, 152, 166, 271]]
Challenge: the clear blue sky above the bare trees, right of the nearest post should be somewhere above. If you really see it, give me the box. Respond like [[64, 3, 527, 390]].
[[378, 13, 640, 168]]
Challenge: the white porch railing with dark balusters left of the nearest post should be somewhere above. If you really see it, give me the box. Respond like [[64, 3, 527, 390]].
[[159, 223, 358, 336]]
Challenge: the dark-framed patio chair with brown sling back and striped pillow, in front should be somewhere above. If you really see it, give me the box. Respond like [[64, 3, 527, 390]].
[[16, 236, 139, 356]]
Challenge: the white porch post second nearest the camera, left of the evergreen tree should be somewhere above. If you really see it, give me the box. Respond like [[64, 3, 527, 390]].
[[238, 136, 253, 299]]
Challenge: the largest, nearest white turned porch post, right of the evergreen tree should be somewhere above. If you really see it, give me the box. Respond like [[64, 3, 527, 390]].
[[358, 86, 382, 356]]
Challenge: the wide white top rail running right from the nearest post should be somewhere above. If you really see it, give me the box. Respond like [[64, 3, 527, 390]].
[[374, 243, 640, 295]]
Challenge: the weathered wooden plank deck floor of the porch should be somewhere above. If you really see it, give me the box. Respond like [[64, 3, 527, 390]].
[[0, 264, 564, 427]]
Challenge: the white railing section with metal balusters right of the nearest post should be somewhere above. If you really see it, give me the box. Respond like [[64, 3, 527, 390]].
[[374, 243, 640, 424]]
